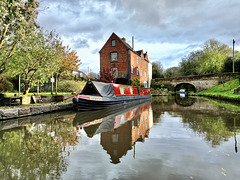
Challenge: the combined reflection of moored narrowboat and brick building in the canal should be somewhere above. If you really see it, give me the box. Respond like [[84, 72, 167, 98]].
[[74, 102, 153, 164]]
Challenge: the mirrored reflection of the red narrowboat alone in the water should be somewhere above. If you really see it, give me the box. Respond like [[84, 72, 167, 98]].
[[73, 100, 152, 137]]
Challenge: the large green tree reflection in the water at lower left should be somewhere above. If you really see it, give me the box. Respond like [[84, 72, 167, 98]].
[[0, 118, 80, 179]]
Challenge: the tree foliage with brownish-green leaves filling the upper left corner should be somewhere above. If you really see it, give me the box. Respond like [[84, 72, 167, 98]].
[[0, 0, 39, 74]]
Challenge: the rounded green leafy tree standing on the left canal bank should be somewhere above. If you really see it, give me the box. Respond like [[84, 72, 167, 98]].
[[7, 30, 59, 94]]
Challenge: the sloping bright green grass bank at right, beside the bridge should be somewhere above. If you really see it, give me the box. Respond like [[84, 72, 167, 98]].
[[194, 79, 240, 99]]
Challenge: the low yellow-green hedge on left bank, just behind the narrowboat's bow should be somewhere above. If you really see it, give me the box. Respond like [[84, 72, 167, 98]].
[[58, 80, 86, 92]]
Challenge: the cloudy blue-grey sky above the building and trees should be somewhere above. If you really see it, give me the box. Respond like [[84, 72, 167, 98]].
[[37, 0, 240, 73]]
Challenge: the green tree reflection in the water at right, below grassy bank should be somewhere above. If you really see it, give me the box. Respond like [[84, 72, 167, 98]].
[[183, 115, 233, 147]]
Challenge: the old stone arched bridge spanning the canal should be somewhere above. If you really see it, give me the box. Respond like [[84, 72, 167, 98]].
[[154, 73, 240, 92]]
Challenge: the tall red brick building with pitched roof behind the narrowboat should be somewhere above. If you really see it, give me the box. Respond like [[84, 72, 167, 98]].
[[99, 33, 152, 87]]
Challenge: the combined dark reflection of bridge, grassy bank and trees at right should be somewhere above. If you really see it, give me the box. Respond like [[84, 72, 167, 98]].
[[152, 96, 240, 149]]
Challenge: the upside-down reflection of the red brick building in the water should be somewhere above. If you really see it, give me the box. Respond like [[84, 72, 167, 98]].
[[101, 103, 151, 164]]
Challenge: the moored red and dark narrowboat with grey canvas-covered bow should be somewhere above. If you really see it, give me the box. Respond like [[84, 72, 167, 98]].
[[73, 81, 152, 111]]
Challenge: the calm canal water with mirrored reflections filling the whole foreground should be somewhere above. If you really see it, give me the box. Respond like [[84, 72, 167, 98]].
[[0, 97, 240, 180]]
